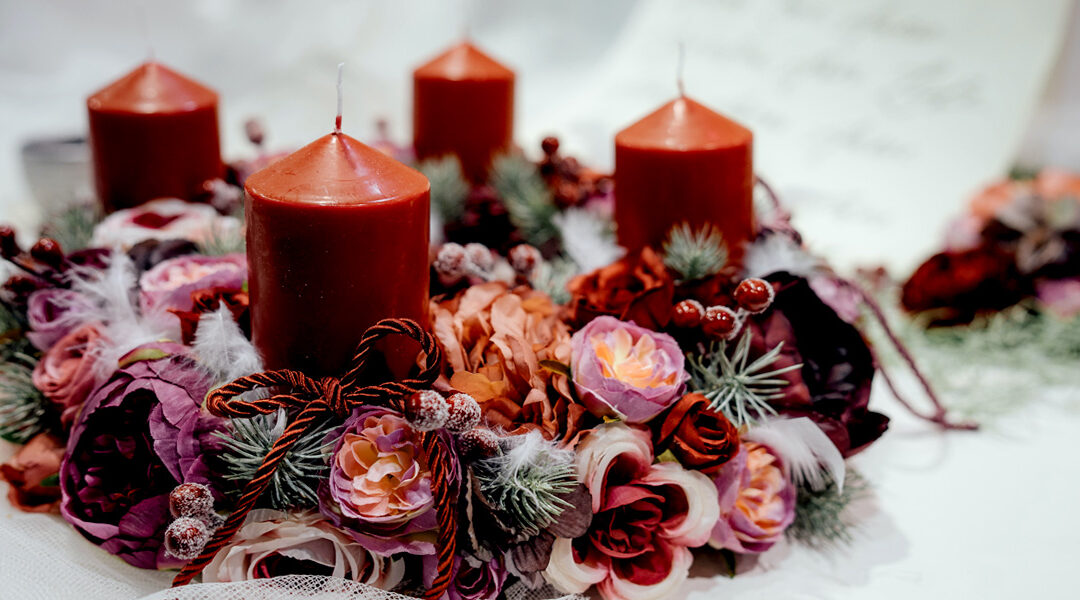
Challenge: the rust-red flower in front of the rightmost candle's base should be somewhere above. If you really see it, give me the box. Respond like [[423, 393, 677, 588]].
[[567, 247, 675, 329]]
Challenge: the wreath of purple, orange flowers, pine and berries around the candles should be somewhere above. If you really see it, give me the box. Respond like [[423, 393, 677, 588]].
[[0, 133, 963, 600]]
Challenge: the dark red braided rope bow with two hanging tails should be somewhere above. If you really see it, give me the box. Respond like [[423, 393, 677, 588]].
[[173, 318, 457, 600]]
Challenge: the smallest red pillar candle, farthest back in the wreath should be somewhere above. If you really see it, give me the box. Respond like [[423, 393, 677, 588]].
[[413, 42, 514, 182]]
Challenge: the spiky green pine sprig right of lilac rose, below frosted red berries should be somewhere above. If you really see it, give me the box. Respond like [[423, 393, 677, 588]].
[[687, 329, 802, 427]]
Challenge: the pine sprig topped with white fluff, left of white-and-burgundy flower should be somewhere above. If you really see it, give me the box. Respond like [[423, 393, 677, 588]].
[[472, 434, 577, 535]]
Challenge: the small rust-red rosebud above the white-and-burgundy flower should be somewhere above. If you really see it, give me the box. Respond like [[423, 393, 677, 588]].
[[654, 394, 739, 475]]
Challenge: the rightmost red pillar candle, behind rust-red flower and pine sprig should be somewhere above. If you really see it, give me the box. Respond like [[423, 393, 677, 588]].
[[615, 96, 755, 261]]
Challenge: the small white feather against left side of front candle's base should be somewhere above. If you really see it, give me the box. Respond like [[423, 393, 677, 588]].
[[192, 304, 262, 383]]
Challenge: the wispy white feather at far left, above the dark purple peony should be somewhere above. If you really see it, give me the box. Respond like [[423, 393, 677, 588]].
[[65, 251, 179, 374]]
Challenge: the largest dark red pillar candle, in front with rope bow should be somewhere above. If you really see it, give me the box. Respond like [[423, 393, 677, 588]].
[[244, 133, 430, 376]]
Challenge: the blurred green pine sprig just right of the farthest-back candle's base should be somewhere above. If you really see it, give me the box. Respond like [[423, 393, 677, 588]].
[[490, 154, 558, 247]]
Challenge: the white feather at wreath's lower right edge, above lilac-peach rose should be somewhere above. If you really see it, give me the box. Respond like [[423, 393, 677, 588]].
[[743, 417, 846, 490]]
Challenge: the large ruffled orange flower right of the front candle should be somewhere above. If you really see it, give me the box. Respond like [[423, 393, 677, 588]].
[[431, 282, 585, 440]]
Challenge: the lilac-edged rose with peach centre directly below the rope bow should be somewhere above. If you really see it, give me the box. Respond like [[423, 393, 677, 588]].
[[319, 407, 459, 556]]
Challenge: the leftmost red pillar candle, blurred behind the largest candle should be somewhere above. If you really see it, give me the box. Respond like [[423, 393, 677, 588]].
[[86, 62, 225, 212]]
